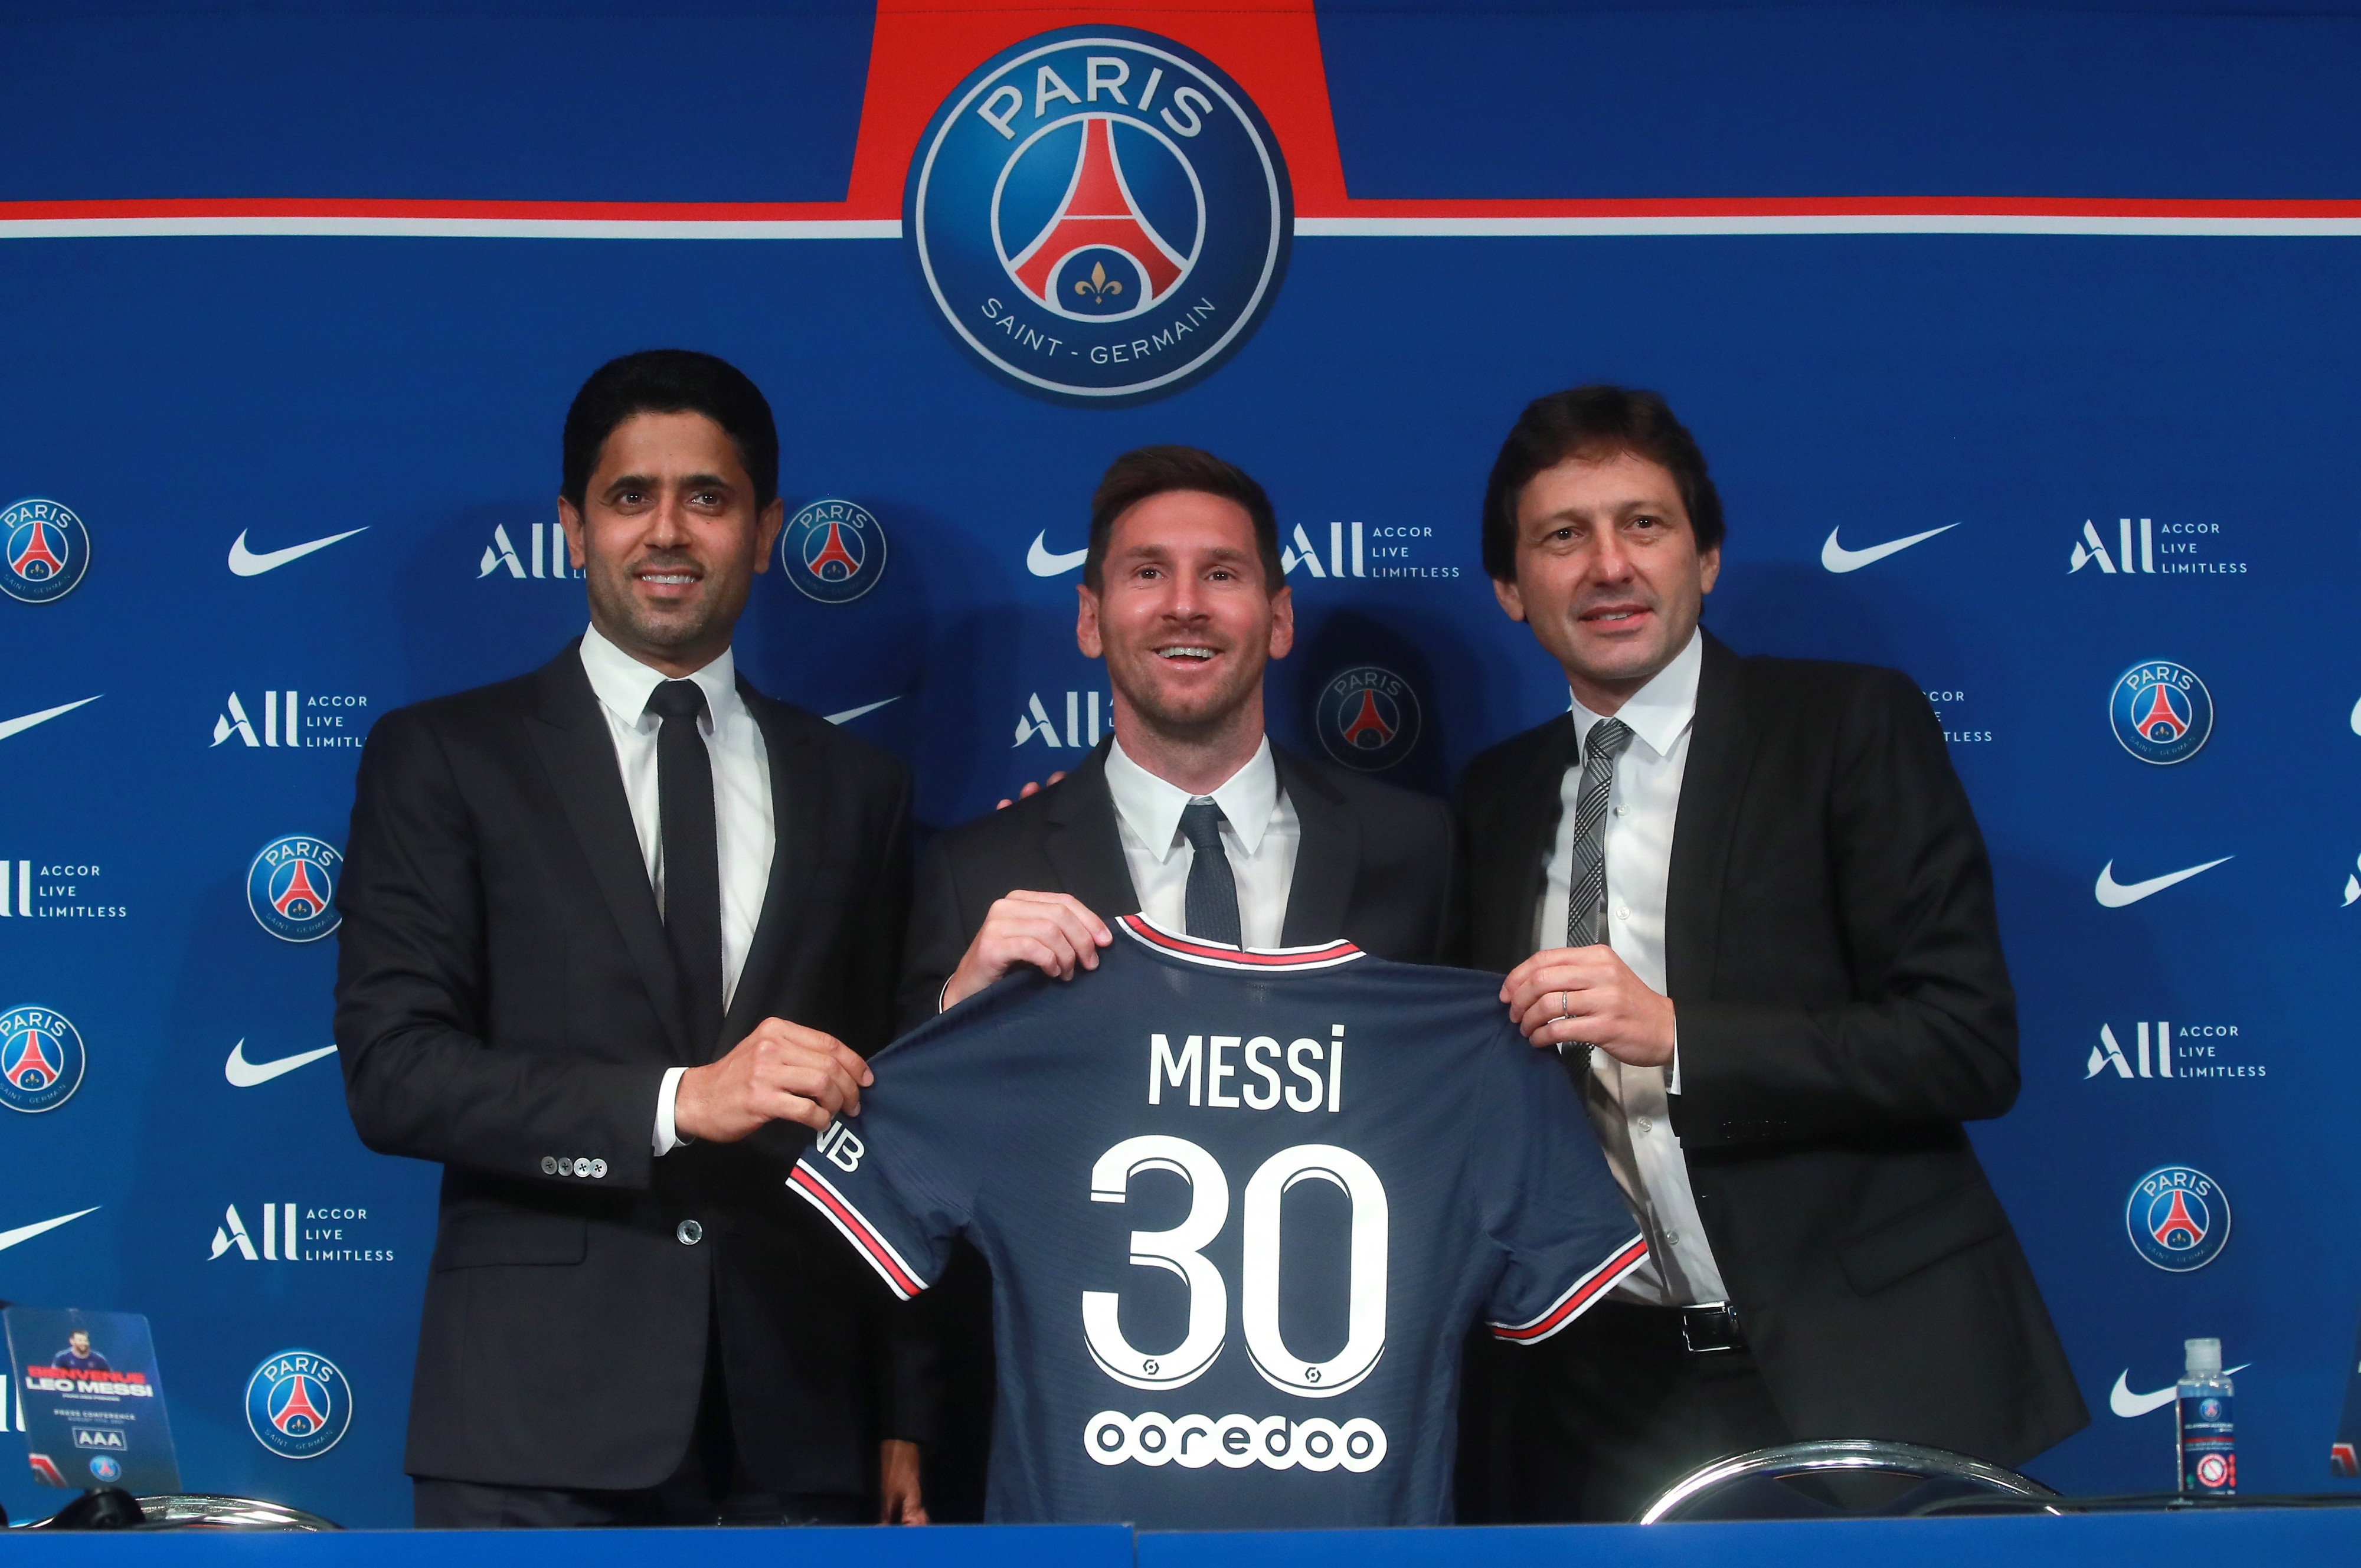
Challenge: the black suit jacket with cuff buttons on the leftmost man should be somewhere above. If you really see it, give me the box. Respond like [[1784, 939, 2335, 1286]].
[[335, 647, 909, 1492]]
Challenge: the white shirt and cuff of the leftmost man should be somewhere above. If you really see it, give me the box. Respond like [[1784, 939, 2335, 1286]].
[[583, 626, 779, 1155]]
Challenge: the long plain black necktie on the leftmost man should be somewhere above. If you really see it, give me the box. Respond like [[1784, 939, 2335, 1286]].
[[647, 680, 722, 1063]]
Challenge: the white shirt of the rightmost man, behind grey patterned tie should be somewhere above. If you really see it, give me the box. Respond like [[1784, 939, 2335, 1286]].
[[1535, 633, 1726, 1306]]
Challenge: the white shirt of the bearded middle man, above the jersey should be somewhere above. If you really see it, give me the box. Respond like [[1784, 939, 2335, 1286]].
[[1093, 734, 1303, 947]]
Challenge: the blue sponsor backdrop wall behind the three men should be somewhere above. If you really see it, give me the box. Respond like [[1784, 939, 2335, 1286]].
[[0, 0, 2361, 1523]]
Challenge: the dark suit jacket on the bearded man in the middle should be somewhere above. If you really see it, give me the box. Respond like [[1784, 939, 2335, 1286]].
[[897, 741, 1457, 1030]]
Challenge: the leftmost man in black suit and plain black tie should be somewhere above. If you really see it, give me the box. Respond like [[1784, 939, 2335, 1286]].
[[335, 349, 923, 1528]]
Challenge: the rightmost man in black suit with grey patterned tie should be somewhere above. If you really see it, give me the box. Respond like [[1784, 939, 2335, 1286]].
[[1459, 387, 2089, 1521]]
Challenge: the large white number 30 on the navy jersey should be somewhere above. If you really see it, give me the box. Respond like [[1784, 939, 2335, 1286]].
[[1081, 1134, 1388, 1398]]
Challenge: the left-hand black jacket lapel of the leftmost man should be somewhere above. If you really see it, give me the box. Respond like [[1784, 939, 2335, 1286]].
[[527, 642, 689, 1060]]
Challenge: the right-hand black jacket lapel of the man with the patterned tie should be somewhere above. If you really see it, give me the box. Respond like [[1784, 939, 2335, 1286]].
[[1665, 630, 1754, 999]]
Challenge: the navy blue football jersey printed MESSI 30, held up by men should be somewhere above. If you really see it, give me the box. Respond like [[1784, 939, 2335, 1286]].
[[791, 916, 1646, 1528]]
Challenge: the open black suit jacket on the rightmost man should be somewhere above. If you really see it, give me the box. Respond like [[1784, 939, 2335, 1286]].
[[1459, 635, 2089, 1464]]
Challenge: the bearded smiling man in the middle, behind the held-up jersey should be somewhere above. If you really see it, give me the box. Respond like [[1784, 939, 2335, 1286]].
[[900, 446, 1454, 1518]]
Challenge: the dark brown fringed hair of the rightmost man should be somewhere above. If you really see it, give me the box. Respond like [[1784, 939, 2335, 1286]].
[[1483, 385, 1724, 583]]
